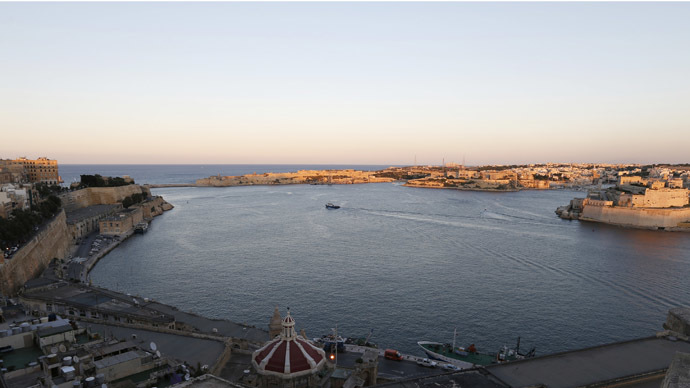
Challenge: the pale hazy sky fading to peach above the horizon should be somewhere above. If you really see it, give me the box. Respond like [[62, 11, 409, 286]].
[[0, 2, 690, 164]]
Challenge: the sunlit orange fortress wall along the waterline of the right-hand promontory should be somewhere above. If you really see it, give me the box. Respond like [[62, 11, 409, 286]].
[[580, 205, 690, 230]]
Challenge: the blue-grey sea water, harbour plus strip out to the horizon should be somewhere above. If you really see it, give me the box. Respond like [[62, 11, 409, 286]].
[[60, 165, 690, 355]]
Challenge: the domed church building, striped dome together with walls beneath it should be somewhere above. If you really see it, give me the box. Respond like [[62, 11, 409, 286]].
[[252, 310, 327, 388]]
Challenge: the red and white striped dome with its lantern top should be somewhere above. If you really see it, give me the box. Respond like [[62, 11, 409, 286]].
[[252, 310, 326, 379]]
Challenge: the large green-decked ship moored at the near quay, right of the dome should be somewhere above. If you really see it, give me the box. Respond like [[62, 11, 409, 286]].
[[417, 337, 536, 367]]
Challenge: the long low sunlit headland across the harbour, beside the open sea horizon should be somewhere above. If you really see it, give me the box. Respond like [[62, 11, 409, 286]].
[[196, 170, 395, 187]]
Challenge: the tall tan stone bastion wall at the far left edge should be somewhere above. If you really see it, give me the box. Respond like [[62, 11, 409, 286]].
[[0, 211, 72, 295]]
